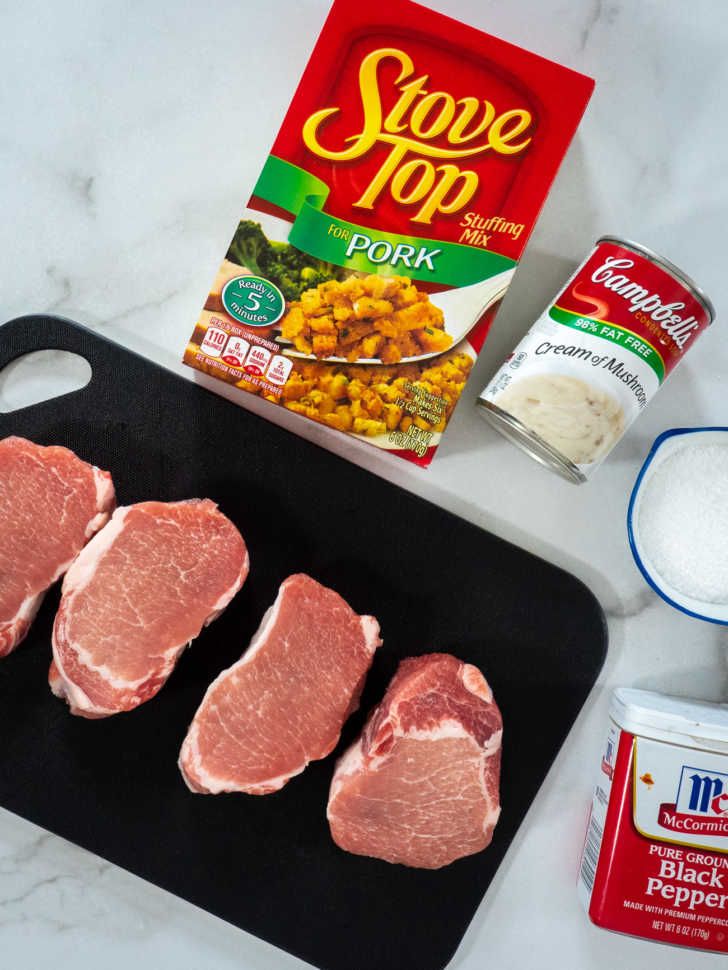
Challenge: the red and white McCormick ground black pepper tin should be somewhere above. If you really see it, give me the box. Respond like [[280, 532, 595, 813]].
[[578, 688, 728, 953]]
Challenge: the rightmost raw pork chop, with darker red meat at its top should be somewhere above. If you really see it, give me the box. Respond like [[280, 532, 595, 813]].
[[328, 653, 503, 869]]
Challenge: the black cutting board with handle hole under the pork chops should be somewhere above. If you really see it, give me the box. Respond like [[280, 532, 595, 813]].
[[0, 316, 606, 970]]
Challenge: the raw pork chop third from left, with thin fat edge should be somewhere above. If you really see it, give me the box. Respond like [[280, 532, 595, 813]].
[[179, 575, 382, 795]]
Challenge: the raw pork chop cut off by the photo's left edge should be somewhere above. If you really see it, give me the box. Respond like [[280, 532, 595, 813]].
[[0, 437, 114, 657]]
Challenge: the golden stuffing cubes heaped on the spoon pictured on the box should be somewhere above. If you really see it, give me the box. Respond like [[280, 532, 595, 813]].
[[281, 276, 452, 364]]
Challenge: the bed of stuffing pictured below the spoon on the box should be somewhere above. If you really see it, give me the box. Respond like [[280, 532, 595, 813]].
[[272, 352, 473, 438]]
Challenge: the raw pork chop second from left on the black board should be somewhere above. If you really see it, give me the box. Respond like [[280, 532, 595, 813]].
[[49, 499, 248, 717]]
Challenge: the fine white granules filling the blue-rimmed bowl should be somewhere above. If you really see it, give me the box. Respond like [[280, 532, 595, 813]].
[[637, 442, 728, 603]]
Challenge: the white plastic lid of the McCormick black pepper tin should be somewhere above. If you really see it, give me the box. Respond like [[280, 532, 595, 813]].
[[609, 687, 728, 754]]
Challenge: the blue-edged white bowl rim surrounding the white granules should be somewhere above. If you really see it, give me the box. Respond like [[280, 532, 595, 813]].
[[627, 428, 728, 626]]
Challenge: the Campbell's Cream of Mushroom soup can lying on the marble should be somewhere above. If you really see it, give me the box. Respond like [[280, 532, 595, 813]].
[[477, 236, 715, 483]]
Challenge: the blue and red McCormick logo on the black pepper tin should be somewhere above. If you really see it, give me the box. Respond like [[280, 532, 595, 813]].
[[659, 765, 728, 838]]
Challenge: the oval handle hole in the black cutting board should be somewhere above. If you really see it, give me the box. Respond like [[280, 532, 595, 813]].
[[0, 350, 93, 414]]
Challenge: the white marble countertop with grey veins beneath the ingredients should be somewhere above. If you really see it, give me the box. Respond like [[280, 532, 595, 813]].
[[0, 0, 728, 970]]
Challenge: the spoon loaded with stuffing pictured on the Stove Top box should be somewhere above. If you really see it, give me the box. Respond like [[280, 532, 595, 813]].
[[275, 267, 515, 366]]
